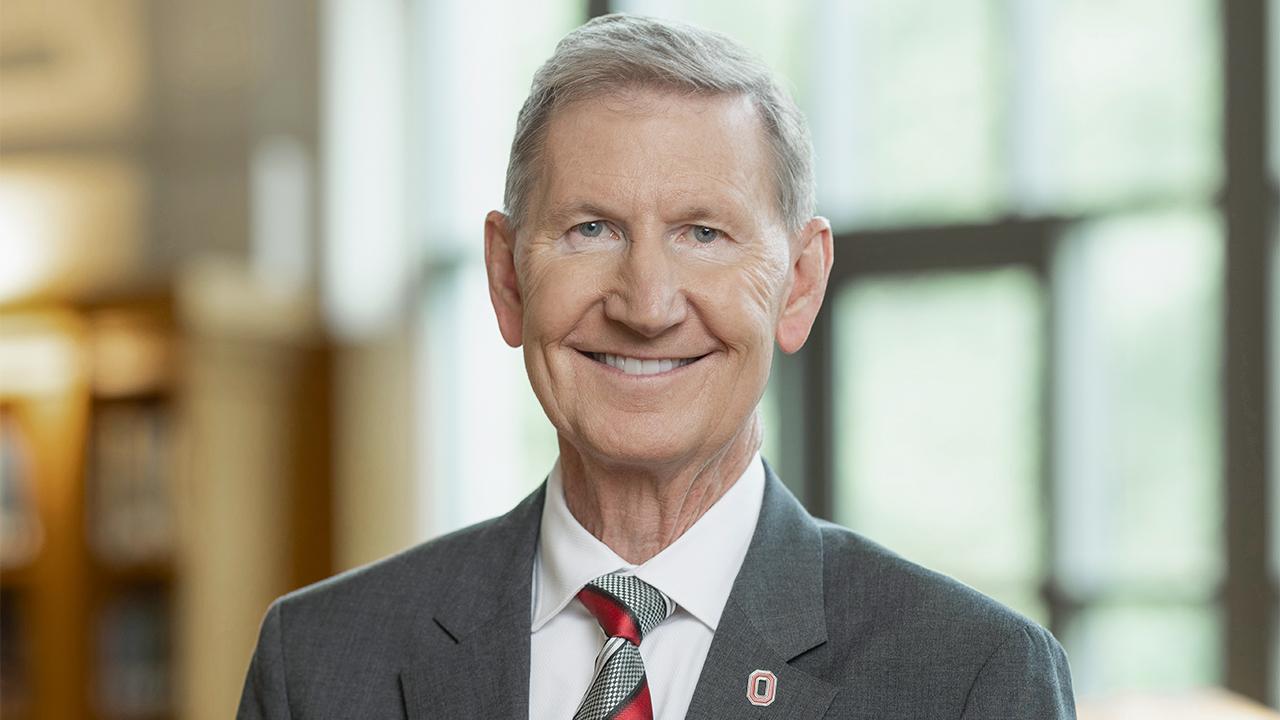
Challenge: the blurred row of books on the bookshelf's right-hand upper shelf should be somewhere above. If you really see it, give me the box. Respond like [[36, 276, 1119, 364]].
[[86, 401, 174, 566]]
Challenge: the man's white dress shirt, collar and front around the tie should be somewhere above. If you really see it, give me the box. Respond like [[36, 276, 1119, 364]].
[[529, 454, 764, 720]]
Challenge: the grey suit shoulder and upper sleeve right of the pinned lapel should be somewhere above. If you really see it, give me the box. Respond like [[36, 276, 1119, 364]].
[[800, 521, 1074, 719]]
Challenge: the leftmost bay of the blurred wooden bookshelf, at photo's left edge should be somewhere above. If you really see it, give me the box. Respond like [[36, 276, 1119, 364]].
[[0, 309, 91, 719]]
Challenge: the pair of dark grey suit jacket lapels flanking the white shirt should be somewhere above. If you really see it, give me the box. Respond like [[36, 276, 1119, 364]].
[[401, 456, 837, 720]]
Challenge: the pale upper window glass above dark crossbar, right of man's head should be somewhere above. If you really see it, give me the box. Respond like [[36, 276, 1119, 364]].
[[616, 0, 1223, 221]]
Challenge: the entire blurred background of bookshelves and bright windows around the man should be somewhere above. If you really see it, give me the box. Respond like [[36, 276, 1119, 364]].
[[0, 0, 1280, 719]]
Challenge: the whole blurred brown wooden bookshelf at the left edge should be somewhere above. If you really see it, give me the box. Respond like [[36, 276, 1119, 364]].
[[0, 299, 177, 719]]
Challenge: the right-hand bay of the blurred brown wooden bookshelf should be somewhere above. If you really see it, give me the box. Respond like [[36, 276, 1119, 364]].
[[82, 299, 178, 719]]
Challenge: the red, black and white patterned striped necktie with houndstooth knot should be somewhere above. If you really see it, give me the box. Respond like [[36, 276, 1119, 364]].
[[573, 574, 676, 720]]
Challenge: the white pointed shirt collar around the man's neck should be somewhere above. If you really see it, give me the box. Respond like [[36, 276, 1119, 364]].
[[532, 452, 764, 632]]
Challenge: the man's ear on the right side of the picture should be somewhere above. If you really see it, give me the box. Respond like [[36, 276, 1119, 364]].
[[776, 218, 835, 354]]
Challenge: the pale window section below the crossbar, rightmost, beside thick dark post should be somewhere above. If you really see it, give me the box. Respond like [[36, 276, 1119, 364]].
[[1053, 210, 1225, 694]]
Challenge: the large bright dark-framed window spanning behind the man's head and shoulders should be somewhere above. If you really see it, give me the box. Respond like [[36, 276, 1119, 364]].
[[410, 0, 1280, 703]]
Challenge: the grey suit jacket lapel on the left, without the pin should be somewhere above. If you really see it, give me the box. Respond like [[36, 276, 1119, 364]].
[[401, 486, 545, 719]]
